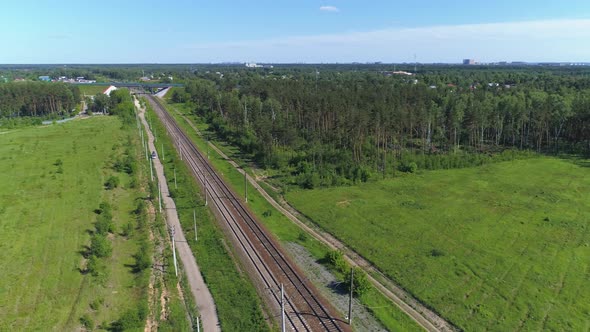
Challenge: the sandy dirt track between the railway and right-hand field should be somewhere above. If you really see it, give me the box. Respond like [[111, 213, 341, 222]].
[[174, 106, 457, 331]]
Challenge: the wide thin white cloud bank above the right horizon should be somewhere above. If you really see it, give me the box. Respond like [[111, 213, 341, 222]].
[[187, 19, 590, 63]]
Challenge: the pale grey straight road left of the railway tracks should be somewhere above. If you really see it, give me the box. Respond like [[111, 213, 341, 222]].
[[136, 101, 221, 332]]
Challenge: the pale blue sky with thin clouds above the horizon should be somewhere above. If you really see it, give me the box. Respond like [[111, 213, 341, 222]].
[[0, 0, 590, 63]]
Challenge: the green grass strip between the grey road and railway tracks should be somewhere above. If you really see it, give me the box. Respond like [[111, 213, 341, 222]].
[[148, 102, 269, 331]]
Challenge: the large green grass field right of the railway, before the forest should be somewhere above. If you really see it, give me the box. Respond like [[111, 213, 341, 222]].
[[287, 158, 590, 331]]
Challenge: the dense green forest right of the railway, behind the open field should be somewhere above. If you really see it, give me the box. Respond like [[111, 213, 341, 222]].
[[172, 67, 590, 188]]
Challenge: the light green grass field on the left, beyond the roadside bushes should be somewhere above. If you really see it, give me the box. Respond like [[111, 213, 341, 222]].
[[0, 117, 144, 331]]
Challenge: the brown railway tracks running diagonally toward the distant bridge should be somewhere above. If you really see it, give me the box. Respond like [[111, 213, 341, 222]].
[[147, 95, 351, 332]]
